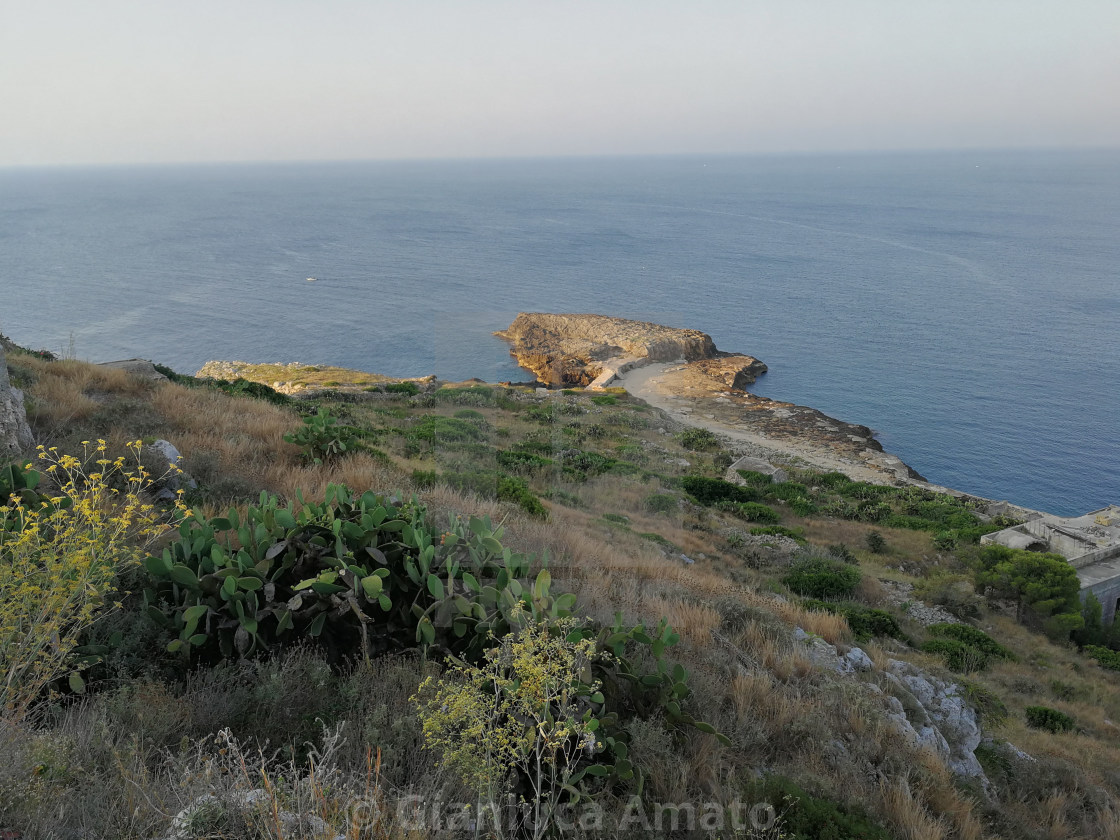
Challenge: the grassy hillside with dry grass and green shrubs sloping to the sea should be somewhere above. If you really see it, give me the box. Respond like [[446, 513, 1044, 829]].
[[0, 344, 1120, 840]]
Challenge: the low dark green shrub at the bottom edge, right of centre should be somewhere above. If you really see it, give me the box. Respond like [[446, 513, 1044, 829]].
[[748, 775, 892, 840]]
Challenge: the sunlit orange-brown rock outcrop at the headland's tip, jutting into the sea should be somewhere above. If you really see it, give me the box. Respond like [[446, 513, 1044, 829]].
[[494, 312, 766, 388]]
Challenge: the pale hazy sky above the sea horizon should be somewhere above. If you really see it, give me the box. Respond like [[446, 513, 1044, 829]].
[[0, 0, 1120, 166]]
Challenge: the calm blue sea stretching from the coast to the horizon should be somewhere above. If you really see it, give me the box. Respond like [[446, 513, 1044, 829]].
[[0, 151, 1120, 514]]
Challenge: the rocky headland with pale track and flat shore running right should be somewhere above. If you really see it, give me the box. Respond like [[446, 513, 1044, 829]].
[[495, 312, 923, 483]]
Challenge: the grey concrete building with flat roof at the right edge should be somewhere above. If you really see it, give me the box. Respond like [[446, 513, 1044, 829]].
[[980, 505, 1120, 624]]
